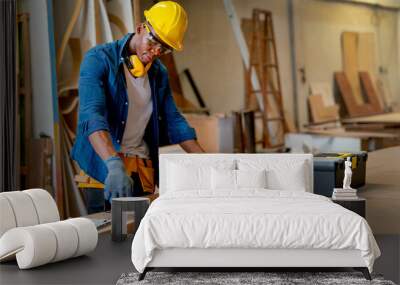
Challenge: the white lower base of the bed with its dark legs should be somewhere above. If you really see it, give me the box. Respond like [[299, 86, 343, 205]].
[[139, 248, 371, 280]]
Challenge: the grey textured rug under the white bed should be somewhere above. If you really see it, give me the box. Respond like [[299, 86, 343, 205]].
[[117, 272, 395, 285]]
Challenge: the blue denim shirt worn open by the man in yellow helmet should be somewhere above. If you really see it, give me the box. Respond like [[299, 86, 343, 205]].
[[71, 34, 196, 183]]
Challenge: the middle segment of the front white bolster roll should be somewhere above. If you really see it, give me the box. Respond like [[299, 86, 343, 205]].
[[43, 221, 78, 262]]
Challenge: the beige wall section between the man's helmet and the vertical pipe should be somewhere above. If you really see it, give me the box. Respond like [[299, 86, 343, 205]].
[[175, 0, 292, 115]]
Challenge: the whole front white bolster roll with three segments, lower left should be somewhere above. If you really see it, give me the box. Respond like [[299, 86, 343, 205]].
[[0, 218, 98, 269]]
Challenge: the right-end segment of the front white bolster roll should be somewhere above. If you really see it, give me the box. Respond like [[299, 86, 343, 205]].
[[64, 218, 98, 257]]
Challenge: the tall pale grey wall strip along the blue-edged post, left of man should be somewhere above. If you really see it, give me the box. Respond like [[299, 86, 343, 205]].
[[18, 0, 54, 138]]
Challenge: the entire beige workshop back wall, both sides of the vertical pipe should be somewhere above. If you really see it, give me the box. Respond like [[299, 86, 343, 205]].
[[173, 0, 400, 125]]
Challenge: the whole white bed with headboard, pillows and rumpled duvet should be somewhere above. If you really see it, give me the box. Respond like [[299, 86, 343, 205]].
[[132, 154, 380, 278]]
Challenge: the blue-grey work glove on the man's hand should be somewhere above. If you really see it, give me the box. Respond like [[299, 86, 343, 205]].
[[104, 156, 133, 202]]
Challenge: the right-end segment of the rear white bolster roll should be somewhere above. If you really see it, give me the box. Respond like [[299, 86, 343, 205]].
[[22, 189, 60, 224]]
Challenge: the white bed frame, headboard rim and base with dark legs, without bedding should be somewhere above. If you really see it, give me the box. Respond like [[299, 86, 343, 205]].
[[139, 154, 371, 280]]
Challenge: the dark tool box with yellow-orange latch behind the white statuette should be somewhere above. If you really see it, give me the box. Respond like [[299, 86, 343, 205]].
[[314, 151, 368, 197]]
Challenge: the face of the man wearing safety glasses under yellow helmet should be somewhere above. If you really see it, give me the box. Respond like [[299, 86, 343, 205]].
[[136, 24, 170, 65]]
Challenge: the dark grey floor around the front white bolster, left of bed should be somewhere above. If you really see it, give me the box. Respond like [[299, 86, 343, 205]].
[[0, 233, 134, 285]]
